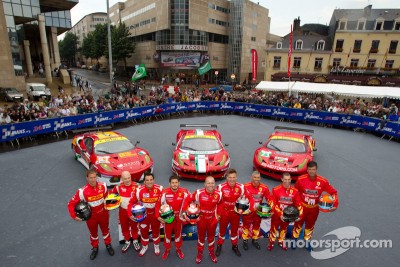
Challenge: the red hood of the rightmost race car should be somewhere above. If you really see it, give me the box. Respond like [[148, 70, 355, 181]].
[[257, 149, 308, 169]]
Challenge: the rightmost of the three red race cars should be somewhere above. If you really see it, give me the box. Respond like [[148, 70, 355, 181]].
[[253, 126, 317, 180]]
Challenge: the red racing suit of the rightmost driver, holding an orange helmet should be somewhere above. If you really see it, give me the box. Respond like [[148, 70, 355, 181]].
[[293, 174, 339, 240]]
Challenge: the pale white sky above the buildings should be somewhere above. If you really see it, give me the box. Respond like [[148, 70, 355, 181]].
[[71, 0, 400, 36]]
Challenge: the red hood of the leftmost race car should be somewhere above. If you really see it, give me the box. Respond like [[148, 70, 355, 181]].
[[95, 148, 153, 172]]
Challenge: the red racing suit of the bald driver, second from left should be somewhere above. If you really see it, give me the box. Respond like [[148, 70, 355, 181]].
[[110, 182, 139, 241]]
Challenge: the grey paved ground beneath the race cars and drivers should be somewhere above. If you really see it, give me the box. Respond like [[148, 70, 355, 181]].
[[0, 115, 400, 266]]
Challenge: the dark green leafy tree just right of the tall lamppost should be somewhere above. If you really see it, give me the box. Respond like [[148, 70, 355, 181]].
[[105, 23, 136, 69]]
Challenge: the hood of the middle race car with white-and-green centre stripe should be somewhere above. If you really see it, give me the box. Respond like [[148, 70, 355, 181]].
[[174, 150, 229, 173]]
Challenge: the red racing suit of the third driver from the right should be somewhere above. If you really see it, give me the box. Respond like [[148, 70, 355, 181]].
[[242, 182, 270, 240]]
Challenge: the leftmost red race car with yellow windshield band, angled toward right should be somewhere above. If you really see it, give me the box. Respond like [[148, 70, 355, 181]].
[[71, 131, 153, 186]]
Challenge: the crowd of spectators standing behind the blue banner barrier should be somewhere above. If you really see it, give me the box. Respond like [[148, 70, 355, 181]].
[[0, 80, 400, 124]]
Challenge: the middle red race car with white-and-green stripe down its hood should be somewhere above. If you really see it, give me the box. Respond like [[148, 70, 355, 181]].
[[172, 124, 230, 180]]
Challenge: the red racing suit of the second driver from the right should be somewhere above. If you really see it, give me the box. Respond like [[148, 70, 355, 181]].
[[269, 184, 303, 244]]
